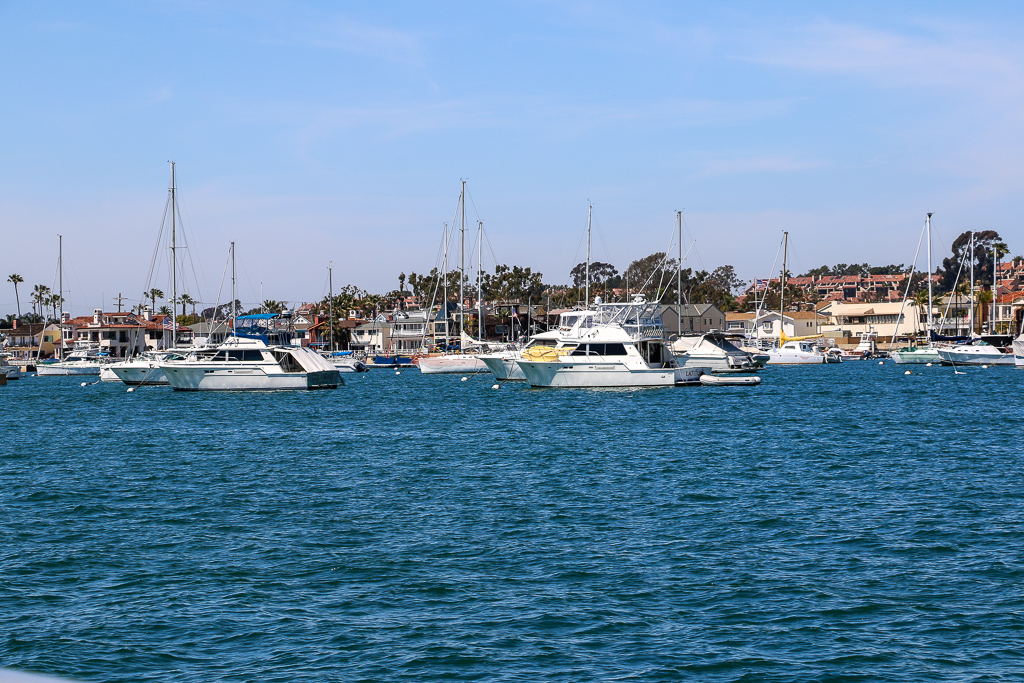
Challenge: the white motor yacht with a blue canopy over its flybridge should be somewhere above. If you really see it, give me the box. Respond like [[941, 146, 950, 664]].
[[160, 313, 344, 391]]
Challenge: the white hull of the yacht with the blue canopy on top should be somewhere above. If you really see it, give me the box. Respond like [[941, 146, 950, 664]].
[[163, 365, 344, 391]]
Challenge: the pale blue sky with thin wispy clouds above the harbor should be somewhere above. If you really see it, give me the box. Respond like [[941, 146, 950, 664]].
[[0, 1, 1024, 314]]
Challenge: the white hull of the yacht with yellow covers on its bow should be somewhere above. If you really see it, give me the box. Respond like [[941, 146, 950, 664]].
[[519, 360, 707, 388]]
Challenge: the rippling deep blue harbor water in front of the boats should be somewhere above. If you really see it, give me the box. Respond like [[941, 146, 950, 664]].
[[0, 362, 1024, 683]]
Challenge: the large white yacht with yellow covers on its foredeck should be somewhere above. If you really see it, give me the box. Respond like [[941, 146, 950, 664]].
[[518, 296, 706, 387]]
